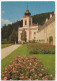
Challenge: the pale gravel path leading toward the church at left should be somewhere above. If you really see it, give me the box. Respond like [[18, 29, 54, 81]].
[[1, 44, 21, 59]]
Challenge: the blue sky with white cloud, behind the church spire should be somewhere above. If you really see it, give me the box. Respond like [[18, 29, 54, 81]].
[[1, 1, 55, 26]]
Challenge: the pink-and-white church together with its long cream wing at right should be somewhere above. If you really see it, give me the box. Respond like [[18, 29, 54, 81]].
[[18, 8, 55, 45]]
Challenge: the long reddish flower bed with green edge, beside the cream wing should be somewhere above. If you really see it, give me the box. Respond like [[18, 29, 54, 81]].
[[27, 44, 55, 54]]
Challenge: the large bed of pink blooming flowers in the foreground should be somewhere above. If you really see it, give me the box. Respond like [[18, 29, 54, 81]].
[[2, 56, 54, 80]]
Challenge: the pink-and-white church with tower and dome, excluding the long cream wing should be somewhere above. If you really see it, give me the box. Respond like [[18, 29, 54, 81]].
[[18, 3, 38, 42]]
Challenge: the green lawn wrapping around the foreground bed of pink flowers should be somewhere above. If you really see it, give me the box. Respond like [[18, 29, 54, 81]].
[[1, 46, 55, 76]]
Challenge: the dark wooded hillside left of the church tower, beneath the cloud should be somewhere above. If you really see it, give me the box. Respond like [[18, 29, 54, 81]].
[[1, 20, 23, 42]]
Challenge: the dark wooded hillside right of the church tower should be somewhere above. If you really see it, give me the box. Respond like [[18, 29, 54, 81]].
[[32, 12, 53, 25]]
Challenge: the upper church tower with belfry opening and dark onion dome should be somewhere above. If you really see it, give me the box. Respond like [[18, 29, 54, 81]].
[[23, 8, 32, 27]]
